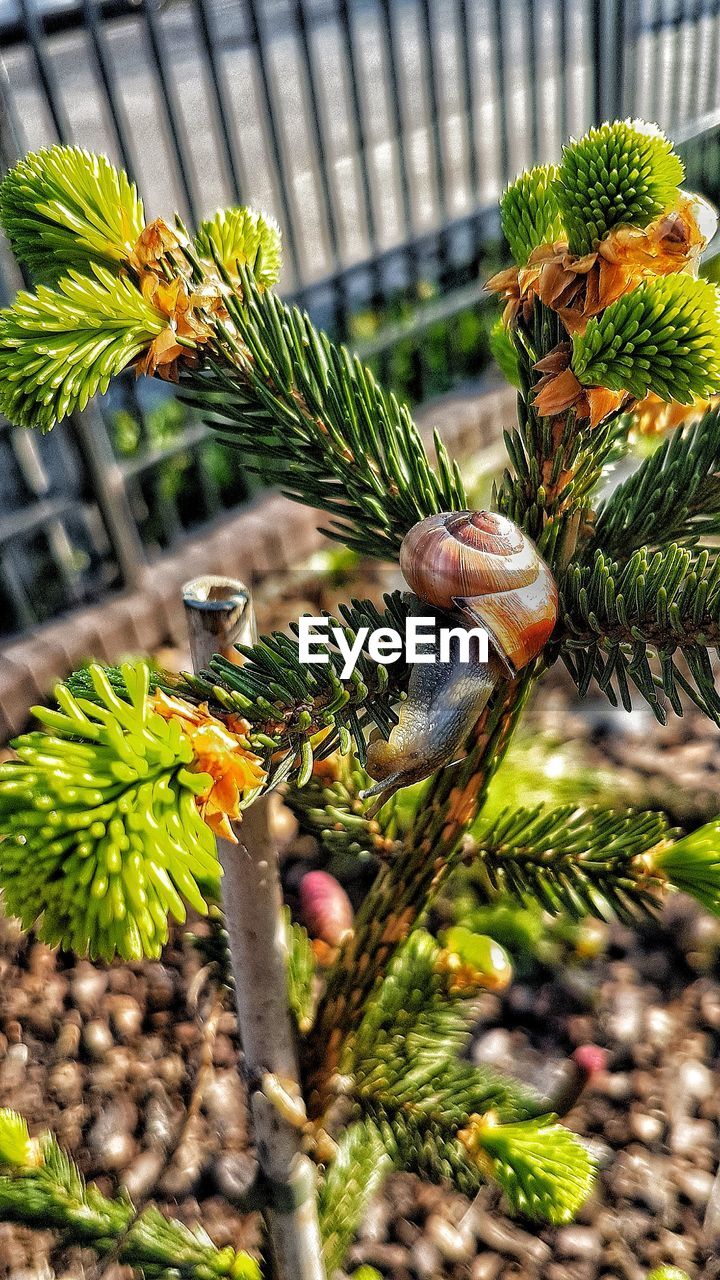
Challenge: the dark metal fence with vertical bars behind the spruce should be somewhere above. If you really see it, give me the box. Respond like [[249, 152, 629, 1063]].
[[0, 0, 720, 635]]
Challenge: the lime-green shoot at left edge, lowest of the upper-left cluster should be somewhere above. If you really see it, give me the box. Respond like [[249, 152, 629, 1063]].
[[0, 266, 168, 431]]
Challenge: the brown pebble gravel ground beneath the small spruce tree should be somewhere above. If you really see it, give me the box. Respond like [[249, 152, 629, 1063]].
[[0, 565, 720, 1280]]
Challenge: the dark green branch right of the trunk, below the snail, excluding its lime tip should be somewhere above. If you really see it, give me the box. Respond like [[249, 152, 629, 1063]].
[[469, 804, 667, 923]]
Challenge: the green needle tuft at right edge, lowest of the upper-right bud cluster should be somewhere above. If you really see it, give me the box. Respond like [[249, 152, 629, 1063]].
[[573, 275, 720, 404]]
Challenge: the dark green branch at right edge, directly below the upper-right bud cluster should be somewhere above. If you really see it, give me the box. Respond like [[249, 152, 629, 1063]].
[[591, 408, 720, 562]]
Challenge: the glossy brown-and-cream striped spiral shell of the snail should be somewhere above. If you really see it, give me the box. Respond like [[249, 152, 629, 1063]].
[[400, 511, 557, 676]]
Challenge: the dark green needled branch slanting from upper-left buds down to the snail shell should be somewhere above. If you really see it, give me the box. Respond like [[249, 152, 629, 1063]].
[[183, 269, 465, 558]]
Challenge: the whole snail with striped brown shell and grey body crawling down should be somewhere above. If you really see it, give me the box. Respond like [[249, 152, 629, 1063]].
[[365, 511, 557, 803]]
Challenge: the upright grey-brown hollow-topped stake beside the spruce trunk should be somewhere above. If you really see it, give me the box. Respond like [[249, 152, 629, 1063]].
[[183, 577, 325, 1280]]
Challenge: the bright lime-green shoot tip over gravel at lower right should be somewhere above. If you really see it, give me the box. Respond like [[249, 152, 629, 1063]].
[[468, 1116, 596, 1224]]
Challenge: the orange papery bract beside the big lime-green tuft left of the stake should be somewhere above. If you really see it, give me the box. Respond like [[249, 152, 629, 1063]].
[[152, 689, 266, 844]]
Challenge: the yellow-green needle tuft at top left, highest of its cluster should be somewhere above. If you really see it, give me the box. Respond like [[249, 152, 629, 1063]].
[[0, 146, 145, 284]]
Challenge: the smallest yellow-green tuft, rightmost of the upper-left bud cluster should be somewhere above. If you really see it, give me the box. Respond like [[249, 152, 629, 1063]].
[[195, 209, 281, 289]]
